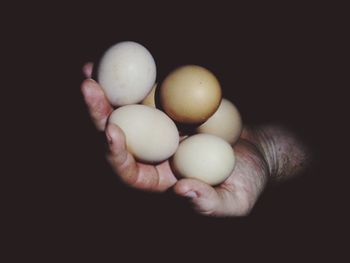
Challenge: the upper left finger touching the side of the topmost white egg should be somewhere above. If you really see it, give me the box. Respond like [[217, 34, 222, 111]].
[[81, 79, 113, 131]]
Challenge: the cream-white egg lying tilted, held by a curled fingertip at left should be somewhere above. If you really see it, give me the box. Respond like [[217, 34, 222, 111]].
[[109, 104, 179, 163]]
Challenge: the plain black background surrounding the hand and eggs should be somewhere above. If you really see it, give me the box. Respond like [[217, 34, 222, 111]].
[[3, 2, 348, 262]]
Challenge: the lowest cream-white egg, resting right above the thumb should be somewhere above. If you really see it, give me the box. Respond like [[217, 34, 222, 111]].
[[171, 134, 235, 185]]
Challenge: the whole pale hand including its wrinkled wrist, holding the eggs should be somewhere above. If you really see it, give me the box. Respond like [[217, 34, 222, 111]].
[[81, 63, 310, 217]]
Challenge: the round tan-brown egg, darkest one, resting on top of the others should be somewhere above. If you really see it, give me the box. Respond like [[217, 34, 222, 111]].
[[160, 65, 221, 124]]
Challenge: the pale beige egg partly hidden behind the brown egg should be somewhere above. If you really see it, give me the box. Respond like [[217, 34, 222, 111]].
[[197, 98, 242, 144]]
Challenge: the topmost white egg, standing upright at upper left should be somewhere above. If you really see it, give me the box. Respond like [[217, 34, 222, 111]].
[[97, 41, 156, 106]]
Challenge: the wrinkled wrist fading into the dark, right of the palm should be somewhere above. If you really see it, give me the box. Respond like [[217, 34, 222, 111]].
[[242, 125, 311, 181]]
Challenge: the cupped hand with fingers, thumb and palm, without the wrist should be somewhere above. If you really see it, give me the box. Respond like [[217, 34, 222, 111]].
[[81, 63, 268, 216]]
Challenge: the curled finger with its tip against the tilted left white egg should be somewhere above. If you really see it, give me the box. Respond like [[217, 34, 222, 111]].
[[106, 124, 139, 185]]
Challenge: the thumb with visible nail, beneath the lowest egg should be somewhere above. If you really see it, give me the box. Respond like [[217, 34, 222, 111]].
[[174, 179, 221, 215]]
